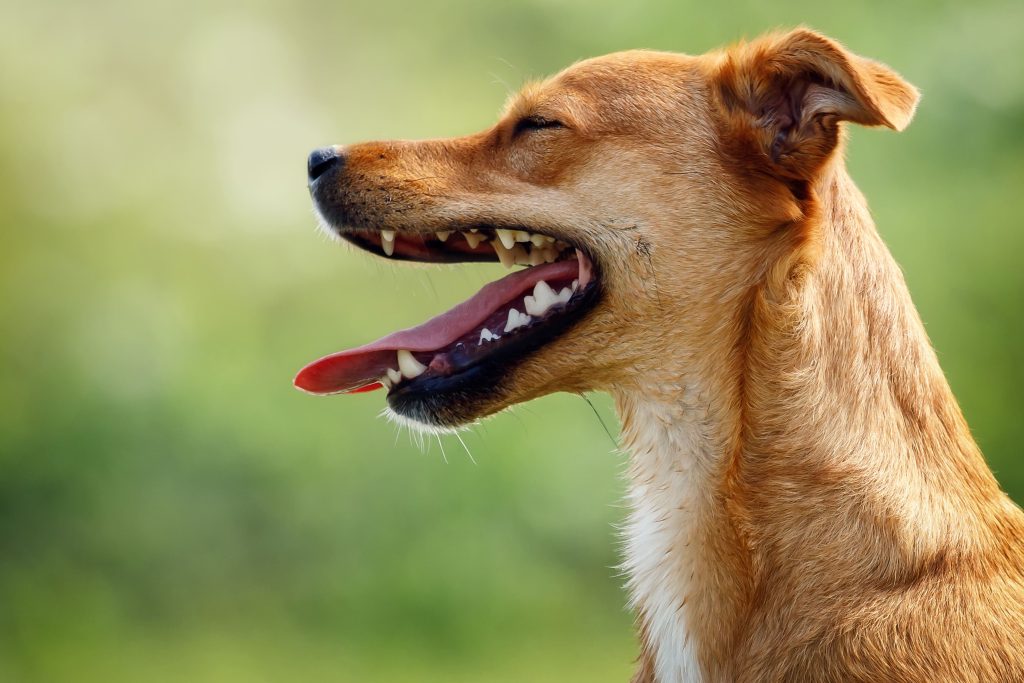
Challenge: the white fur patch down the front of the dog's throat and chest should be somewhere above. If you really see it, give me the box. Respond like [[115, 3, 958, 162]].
[[623, 395, 710, 683]]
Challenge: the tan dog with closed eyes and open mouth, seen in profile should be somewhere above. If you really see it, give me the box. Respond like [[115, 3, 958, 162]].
[[295, 29, 1024, 683]]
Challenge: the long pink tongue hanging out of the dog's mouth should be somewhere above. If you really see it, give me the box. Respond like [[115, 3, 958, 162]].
[[295, 255, 590, 394]]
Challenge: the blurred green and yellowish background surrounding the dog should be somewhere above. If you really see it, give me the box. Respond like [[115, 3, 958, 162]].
[[0, 0, 1024, 683]]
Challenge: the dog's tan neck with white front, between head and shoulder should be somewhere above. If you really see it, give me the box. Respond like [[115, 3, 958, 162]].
[[613, 162, 1009, 683]]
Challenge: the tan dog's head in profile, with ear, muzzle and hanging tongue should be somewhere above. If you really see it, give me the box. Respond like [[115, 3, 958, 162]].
[[296, 30, 918, 427]]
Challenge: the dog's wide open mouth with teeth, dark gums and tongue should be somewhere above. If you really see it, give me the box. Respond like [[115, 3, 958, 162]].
[[295, 226, 600, 404]]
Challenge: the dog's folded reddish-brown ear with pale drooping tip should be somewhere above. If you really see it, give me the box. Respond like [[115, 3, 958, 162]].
[[715, 29, 919, 180]]
